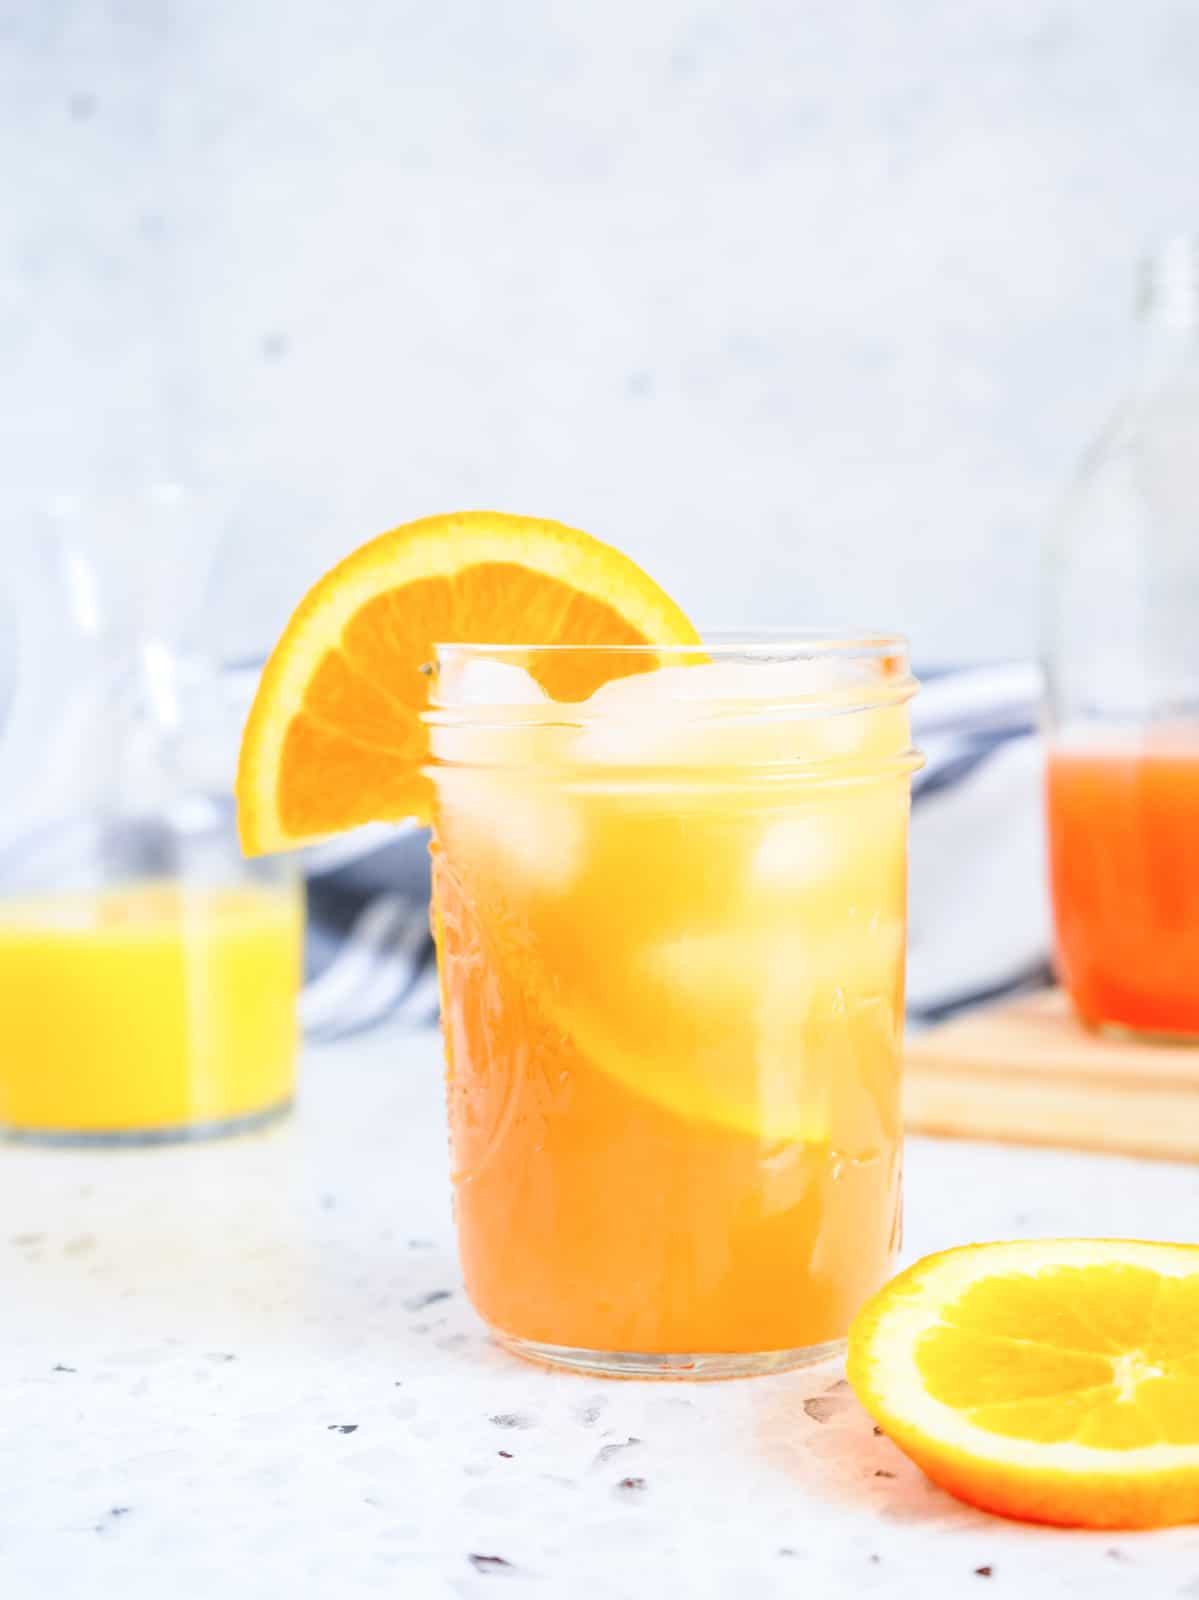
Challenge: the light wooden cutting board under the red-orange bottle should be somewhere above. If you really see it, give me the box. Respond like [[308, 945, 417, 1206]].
[[904, 990, 1199, 1162]]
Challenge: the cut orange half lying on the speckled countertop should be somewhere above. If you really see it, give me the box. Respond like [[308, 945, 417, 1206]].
[[848, 1238, 1199, 1528]]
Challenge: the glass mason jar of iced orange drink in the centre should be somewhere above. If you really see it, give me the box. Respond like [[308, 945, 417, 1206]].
[[427, 634, 916, 1378]]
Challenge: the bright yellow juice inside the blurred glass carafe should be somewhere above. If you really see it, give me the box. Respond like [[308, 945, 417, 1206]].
[[0, 882, 303, 1136]]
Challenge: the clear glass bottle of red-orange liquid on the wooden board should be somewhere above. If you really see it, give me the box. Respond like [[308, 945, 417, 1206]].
[[1045, 237, 1199, 1040]]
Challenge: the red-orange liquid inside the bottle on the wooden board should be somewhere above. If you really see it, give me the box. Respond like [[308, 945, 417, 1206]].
[[1047, 736, 1199, 1037]]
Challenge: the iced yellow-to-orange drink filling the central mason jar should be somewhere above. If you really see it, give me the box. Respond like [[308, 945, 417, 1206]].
[[434, 773, 906, 1354]]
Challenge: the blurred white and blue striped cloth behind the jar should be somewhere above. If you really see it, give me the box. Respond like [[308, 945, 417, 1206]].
[[301, 664, 1050, 1040]]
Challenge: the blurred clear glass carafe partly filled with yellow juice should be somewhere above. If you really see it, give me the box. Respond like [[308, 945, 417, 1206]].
[[0, 486, 303, 1142]]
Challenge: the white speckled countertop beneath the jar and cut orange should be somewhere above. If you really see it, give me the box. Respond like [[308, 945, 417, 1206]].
[[0, 1034, 1199, 1600]]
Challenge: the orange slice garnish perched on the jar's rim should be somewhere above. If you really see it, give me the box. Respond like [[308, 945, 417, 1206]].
[[237, 512, 696, 854]]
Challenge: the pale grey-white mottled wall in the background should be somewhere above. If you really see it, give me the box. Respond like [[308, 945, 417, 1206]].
[[0, 0, 1199, 661]]
